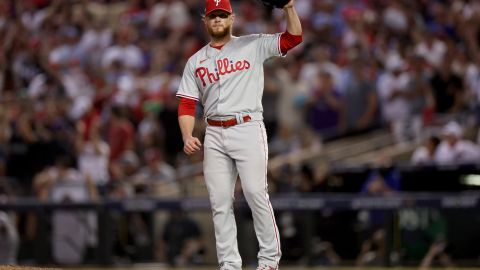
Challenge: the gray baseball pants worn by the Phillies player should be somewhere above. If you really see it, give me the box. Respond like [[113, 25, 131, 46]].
[[203, 121, 281, 270]]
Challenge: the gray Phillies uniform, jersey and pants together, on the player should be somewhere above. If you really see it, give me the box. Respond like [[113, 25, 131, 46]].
[[177, 34, 281, 270]]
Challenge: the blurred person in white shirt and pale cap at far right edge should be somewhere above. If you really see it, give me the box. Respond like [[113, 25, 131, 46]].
[[435, 122, 480, 165]]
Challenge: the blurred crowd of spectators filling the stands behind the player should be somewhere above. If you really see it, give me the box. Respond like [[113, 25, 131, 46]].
[[0, 0, 480, 266]]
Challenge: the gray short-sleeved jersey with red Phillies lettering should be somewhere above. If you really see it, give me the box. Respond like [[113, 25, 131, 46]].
[[177, 34, 281, 118]]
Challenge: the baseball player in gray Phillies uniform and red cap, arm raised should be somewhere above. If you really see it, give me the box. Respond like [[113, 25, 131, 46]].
[[177, 0, 302, 270]]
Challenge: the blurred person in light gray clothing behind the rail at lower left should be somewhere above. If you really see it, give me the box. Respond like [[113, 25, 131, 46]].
[[34, 156, 98, 264]]
